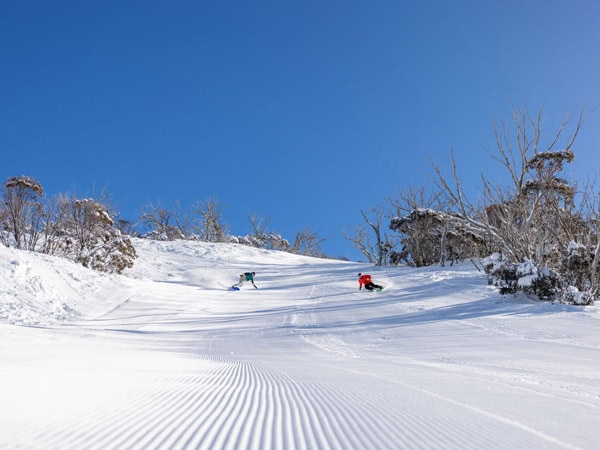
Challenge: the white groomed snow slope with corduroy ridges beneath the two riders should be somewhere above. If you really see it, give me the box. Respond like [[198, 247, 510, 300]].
[[0, 240, 600, 449]]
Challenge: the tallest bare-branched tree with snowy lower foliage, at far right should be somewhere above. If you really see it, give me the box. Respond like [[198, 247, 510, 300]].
[[434, 108, 598, 298]]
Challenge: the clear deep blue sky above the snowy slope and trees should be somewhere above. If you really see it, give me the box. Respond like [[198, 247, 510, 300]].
[[0, 0, 600, 258]]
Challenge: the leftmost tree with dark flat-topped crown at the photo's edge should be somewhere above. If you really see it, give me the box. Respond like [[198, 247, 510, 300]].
[[0, 176, 44, 250]]
